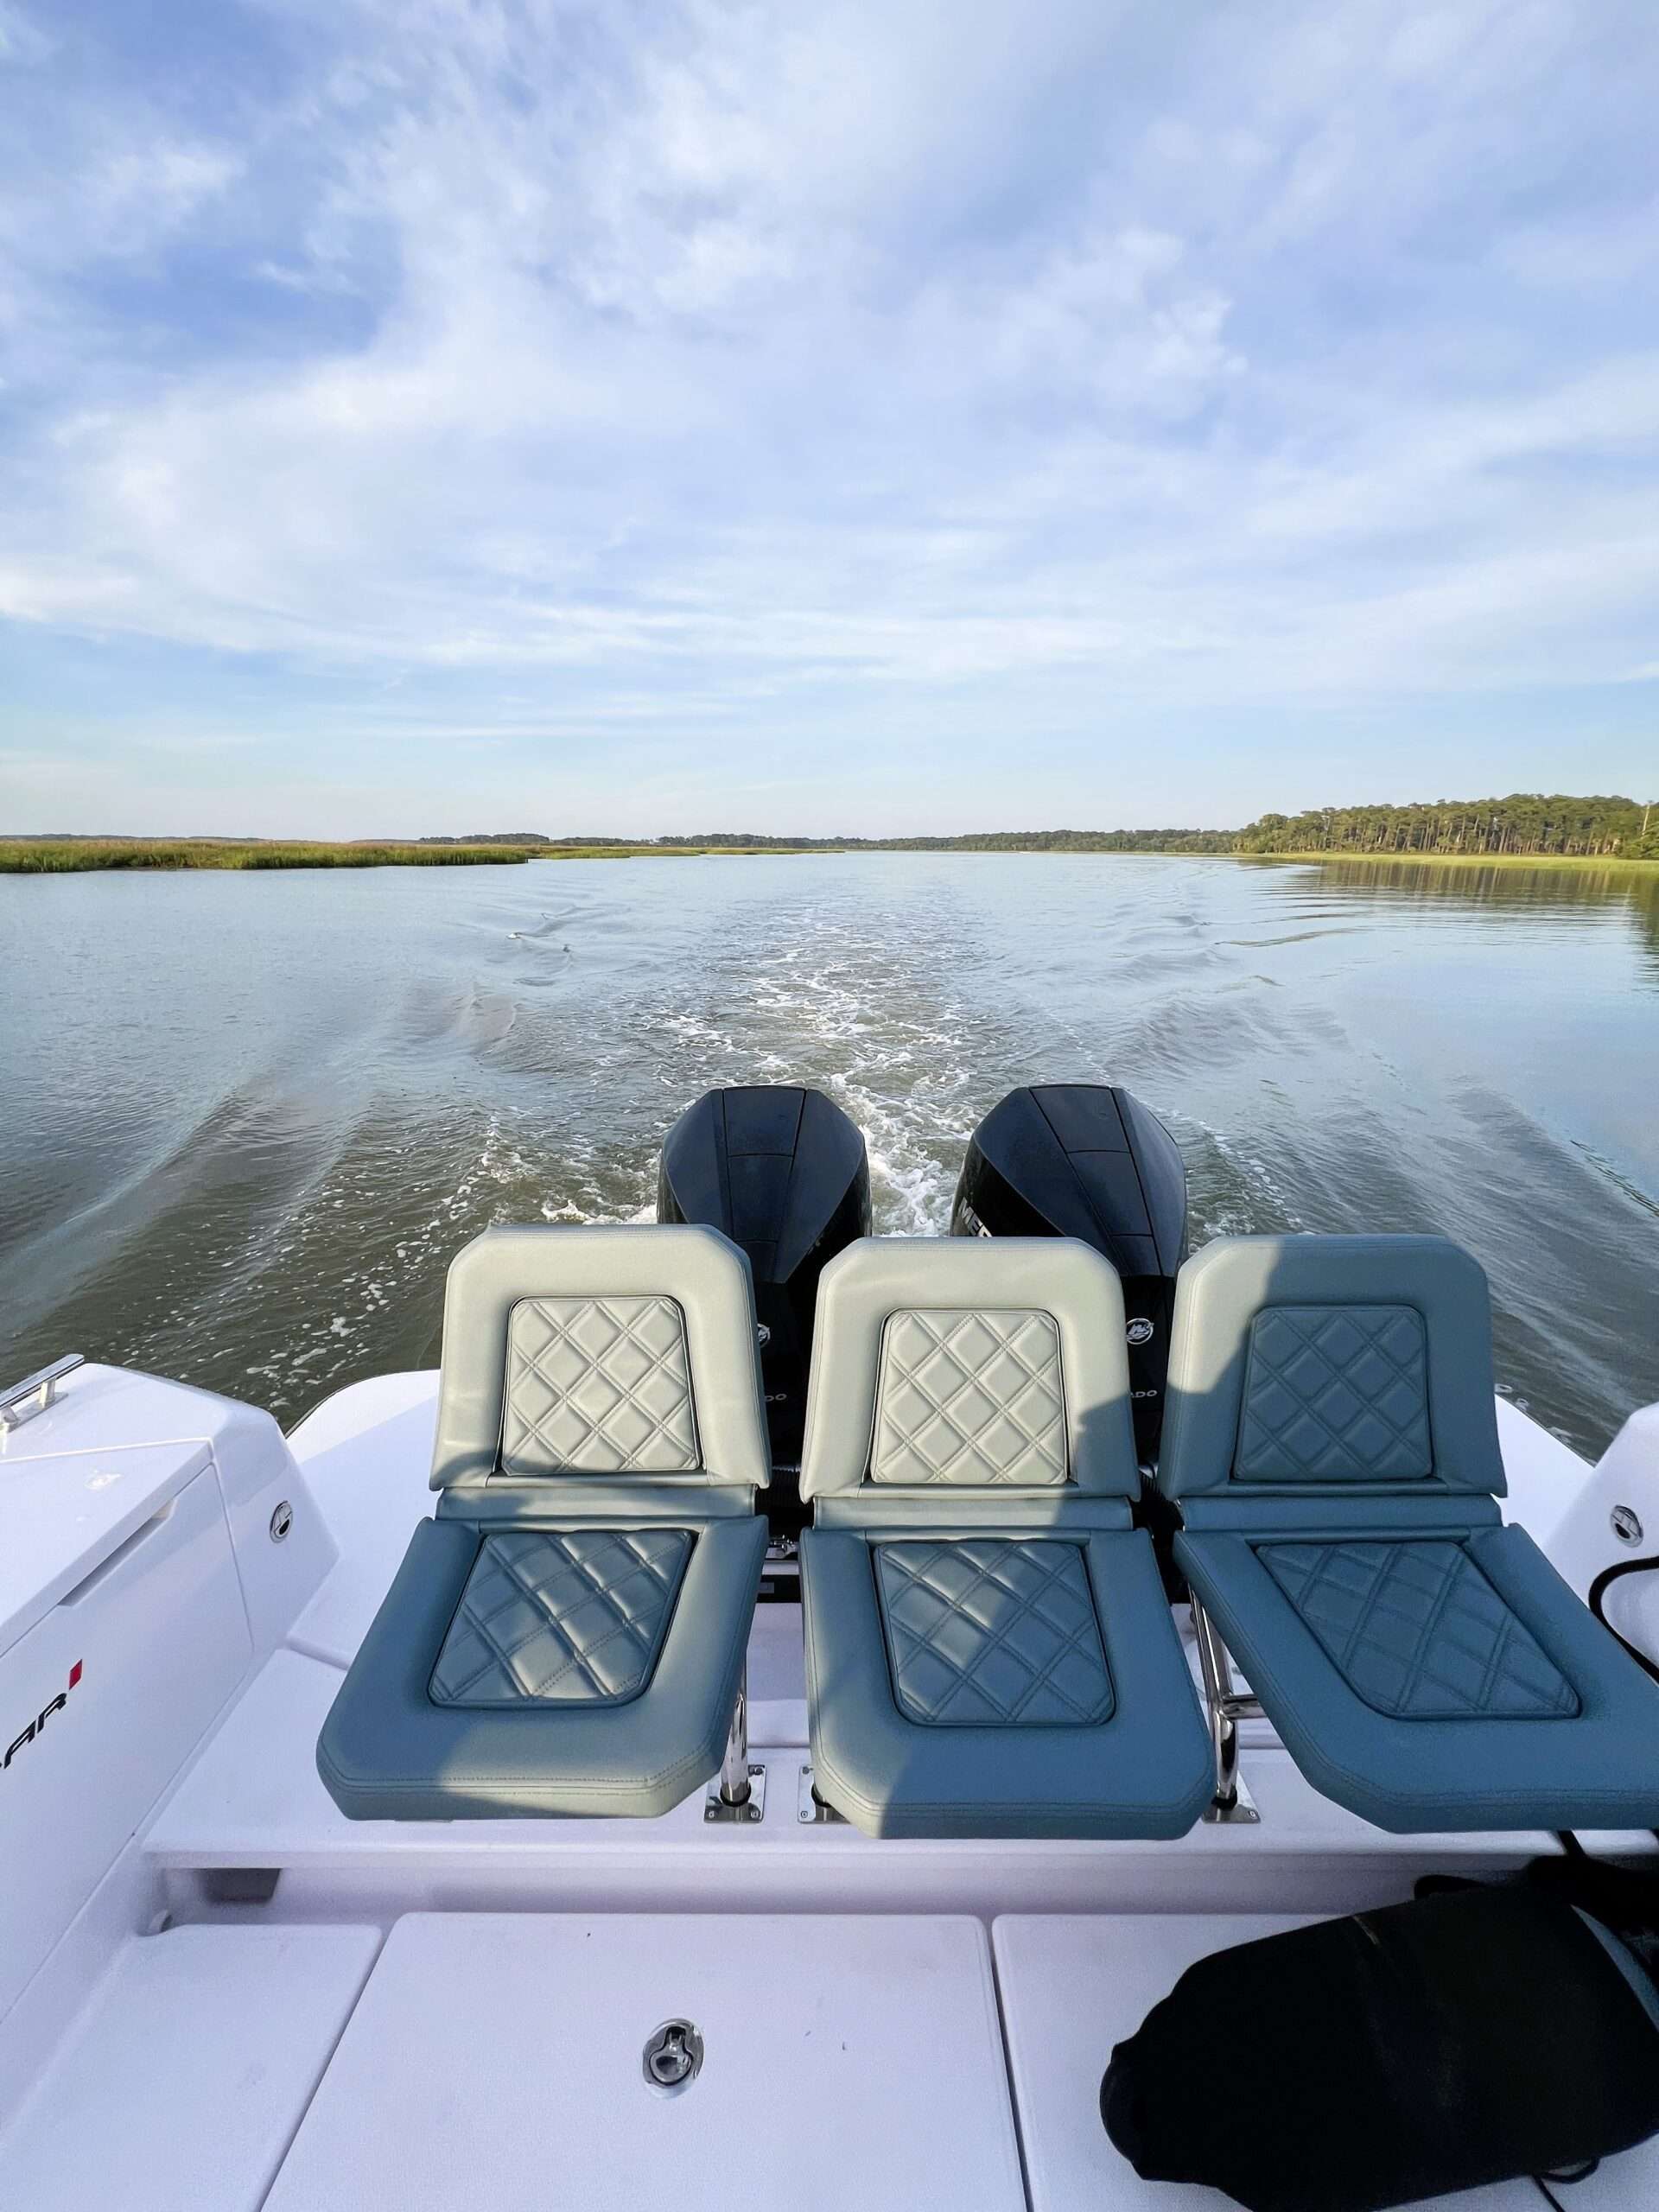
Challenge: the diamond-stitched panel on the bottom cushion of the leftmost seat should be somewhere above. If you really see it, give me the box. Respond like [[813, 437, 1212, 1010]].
[[427, 1529, 692, 1706]]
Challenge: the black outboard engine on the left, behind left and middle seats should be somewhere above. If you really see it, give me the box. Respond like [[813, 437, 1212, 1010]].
[[657, 1084, 869, 1535]]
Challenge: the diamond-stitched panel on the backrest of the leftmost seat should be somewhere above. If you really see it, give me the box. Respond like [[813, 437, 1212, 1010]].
[[500, 1299, 699, 1476]]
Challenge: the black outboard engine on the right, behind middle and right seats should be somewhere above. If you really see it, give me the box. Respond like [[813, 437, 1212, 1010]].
[[951, 1084, 1185, 1460]]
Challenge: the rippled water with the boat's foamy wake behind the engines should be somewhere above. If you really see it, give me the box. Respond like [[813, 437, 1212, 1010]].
[[0, 854, 1659, 1449]]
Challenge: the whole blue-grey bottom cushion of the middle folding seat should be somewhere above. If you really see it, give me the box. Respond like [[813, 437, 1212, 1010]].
[[801, 1529, 1214, 1838]]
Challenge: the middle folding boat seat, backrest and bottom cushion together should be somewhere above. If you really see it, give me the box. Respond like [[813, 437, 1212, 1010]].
[[801, 1236, 1210, 1836]]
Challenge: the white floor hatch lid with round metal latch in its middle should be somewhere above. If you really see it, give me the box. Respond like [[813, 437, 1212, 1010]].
[[265, 1913, 1027, 2212]]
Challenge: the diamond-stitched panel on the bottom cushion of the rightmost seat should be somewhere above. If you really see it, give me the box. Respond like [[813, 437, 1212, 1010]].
[[1256, 1540, 1580, 1721]]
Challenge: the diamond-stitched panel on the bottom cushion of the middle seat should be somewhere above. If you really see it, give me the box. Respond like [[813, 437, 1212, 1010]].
[[874, 1537, 1115, 1727]]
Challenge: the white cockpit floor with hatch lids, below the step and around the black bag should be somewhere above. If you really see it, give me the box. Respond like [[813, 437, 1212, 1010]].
[[13, 1911, 1659, 2212]]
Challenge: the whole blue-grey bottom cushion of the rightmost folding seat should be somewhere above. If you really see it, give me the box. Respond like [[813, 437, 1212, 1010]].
[[1174, 1524, 1659, 1834]]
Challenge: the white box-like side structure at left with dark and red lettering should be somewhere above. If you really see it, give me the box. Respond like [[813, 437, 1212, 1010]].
[[0, 1365, 336, 2018]]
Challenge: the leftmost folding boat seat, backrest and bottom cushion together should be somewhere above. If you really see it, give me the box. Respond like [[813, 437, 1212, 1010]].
[[316, 1228, 770, 1821]]
